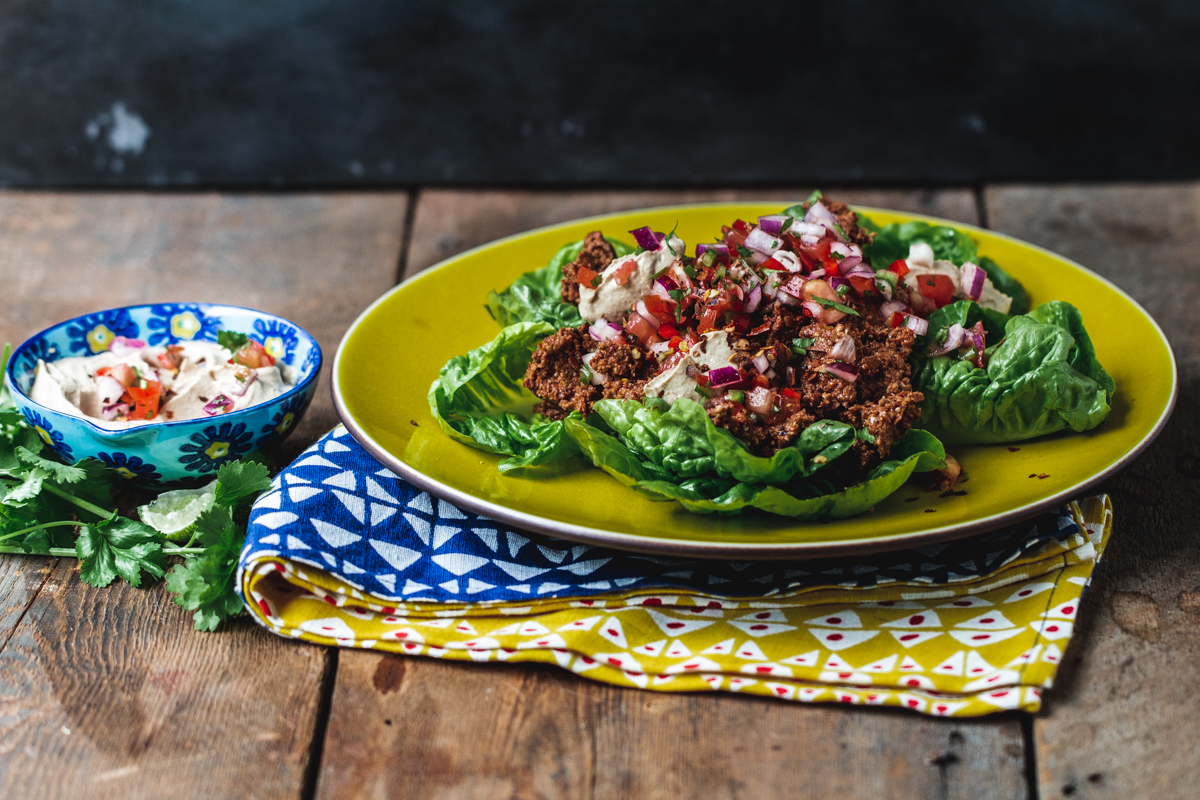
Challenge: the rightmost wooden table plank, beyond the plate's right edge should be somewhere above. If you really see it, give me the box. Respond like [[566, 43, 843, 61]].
[[986, 184, 1200, 798]]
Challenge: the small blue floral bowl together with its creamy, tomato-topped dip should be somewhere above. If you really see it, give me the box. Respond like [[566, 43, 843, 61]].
[[4, 303, 322, 488]]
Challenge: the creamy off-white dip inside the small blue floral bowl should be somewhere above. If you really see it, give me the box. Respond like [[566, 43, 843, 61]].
[[29, 342, 298, 431]]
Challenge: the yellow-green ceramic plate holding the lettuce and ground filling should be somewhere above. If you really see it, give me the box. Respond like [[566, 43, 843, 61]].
[[334, 201, 1176, 559]]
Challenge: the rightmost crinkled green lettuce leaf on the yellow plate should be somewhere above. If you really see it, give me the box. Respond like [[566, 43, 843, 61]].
[[913, 301, 1115, 445]]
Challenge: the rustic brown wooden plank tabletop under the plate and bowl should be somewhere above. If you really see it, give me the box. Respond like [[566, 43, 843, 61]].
[[0, 184, 1200, 799]]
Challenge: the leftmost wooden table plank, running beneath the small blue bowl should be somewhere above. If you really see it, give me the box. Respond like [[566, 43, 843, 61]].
[[0, 193, 407, 798]]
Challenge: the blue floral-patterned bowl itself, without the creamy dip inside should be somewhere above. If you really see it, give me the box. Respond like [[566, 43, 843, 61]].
[[4, 302, 320, 488]]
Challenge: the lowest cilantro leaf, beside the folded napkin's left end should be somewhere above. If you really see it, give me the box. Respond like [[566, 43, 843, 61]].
[[166, 510, 245, 631]]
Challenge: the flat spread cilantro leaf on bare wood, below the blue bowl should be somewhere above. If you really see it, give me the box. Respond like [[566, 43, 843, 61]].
[[76, 517, 167, 588]]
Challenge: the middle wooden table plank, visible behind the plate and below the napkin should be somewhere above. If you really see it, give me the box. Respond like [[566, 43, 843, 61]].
[[317, 190, 1027, 799]]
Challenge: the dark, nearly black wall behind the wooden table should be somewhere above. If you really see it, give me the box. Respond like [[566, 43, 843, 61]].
[[0, 0, 1200, 187]]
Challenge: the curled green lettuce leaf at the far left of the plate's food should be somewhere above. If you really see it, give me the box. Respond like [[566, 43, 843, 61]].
[[430, 321, 578, 471]]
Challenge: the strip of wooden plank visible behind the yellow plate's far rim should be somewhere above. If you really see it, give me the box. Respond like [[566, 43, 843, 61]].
[[404, 187, 977, 277]]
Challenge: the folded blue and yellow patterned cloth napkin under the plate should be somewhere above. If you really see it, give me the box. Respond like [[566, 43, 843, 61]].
[[238, 426, 1112, 716]]
